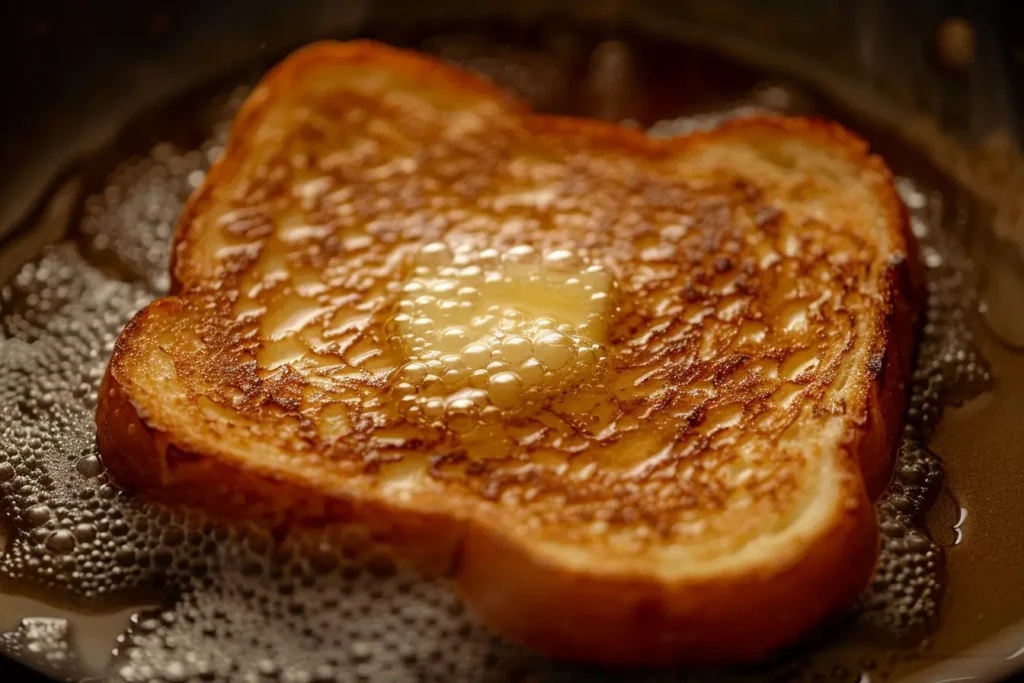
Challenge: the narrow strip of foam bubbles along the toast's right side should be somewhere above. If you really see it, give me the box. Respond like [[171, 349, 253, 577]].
[[863, 178, 991, 635]]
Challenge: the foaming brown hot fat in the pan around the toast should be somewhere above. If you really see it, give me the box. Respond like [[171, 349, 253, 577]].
[[0, 26, 1024, 681]]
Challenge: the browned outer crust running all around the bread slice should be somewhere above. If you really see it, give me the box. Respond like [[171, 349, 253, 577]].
[[97, 42, 923, 664]]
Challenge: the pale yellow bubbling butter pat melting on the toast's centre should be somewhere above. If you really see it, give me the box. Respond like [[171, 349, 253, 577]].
[[389, 243, 614, 432]]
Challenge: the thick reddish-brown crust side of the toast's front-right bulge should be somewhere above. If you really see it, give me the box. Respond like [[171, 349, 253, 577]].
[[459, 485, 878, 666]]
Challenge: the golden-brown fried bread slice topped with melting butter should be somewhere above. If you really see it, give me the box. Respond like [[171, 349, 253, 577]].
[[97, 42, 921, 664]]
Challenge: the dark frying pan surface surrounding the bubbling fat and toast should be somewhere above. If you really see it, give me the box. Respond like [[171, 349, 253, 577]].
[[0, 0, 1024, 683]]
